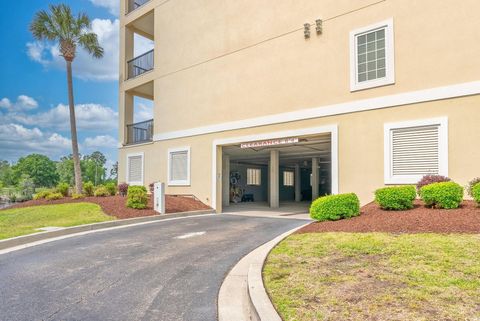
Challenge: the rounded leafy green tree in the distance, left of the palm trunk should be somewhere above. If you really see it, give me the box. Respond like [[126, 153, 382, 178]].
[[13, 154, 58, 187]]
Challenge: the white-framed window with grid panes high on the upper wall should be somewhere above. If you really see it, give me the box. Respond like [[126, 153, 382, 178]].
[[350, 18, 395, 91]]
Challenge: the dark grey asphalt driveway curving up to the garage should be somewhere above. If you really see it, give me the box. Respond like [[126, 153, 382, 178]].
[[0, 215, 306, 321]]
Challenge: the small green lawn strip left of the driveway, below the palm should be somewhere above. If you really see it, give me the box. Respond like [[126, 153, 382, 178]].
[[0, 203, 115, 239]]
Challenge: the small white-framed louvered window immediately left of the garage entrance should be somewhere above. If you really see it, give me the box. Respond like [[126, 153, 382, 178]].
[[168, 147, 190, 186]]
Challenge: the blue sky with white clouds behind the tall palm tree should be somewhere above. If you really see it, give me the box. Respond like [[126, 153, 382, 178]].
[[0, 0, 151, 170]]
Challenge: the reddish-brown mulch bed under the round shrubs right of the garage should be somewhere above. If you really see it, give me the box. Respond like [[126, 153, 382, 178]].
[[297, 201, 480, 234]]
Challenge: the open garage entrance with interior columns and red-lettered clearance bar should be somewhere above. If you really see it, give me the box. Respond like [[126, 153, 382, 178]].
[[222, 133, 332, 213]]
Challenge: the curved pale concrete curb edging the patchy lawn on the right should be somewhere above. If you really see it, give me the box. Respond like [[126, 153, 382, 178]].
[[218, 222, 310, 321]]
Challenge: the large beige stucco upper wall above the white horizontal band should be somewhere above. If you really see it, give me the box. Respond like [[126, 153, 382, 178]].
[[142, 0, 480, 133]]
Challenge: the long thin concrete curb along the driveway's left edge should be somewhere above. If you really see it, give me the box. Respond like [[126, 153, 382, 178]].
[[0, 210, 215, 251]]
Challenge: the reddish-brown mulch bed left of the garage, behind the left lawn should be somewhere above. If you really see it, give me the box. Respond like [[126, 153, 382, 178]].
[[3, 195, 211, 219]]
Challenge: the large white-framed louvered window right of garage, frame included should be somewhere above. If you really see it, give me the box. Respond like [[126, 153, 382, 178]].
[[384, 117, 448, 184]]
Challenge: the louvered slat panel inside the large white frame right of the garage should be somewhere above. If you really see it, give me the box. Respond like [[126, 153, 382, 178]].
[[391, 125, 440, 176]]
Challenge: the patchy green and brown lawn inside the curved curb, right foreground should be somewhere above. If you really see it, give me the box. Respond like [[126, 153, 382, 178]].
[[263, 233, 480, 321]]
